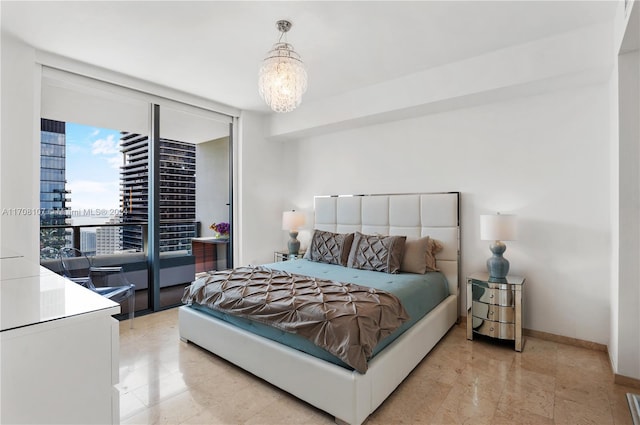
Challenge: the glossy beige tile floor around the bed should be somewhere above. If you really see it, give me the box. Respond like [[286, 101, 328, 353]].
[[118, 309, 638, 425]]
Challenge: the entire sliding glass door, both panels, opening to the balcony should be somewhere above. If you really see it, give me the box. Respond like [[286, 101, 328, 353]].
[[40, 68, 233, 314]]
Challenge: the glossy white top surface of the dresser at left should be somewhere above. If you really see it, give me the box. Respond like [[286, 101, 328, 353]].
[[0, 257, 120, 332]]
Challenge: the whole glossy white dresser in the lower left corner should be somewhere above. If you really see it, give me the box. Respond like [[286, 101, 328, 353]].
[[0, 252, 120, 424]]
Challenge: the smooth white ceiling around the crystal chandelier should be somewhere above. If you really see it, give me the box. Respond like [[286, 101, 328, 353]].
[[0, 0, 616, 111]]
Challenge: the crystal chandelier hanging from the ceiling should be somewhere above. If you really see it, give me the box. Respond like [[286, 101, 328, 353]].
[[258, 21, 307, 112]]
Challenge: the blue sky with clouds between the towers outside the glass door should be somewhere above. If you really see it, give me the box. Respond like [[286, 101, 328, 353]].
[[66, 122, 122, 222]]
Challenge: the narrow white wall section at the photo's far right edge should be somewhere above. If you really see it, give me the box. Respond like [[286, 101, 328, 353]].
[[608, 2, 640, 379]]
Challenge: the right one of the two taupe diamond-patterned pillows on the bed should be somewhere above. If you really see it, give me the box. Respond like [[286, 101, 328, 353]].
[[347, 232, 407, 273]]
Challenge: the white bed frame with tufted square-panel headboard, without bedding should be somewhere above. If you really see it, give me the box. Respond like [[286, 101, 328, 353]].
[[179, 192, 460, 425]]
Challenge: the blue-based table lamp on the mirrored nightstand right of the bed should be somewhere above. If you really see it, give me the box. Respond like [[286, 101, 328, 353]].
[[480, 213, 516, 282]]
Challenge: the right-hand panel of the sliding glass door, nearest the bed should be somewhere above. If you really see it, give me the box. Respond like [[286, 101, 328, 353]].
[[151, 104, 233, 308]]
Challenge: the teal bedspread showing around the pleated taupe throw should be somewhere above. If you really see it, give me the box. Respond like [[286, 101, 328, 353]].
[[191, 259, 449, 369]]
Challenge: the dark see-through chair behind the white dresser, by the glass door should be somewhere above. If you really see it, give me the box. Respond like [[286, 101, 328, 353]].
[[59, 248, 136, 328]]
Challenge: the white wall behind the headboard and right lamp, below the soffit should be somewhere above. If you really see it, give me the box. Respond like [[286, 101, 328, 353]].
[[283, 84, 610, 344]]
